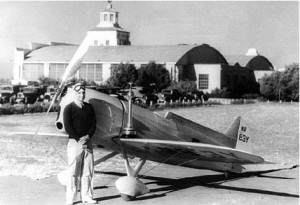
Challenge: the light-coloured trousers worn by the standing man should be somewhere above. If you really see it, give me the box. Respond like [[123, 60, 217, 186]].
[[66, 139, 94, 202]]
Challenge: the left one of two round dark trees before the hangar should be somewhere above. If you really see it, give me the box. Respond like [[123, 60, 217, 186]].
[[107, 63, 138, 87]]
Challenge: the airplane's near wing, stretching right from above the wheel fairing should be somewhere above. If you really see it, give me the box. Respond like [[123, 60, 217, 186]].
[[121, 138, 264, 164]]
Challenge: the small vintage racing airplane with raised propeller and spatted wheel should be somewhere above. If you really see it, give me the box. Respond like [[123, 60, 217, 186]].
[[31, 38, 294, 200]]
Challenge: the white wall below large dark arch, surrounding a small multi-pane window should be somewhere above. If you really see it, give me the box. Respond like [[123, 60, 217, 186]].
[[194, 64, 221, 93]]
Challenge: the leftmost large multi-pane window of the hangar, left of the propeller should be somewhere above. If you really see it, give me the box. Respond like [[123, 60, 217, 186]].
[[22, 63, 44, 80]]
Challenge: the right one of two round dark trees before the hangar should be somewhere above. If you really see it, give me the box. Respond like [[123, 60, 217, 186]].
[[136, 61, 171, 92]]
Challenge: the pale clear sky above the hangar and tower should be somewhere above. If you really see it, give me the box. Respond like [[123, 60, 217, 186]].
[[0, 0, 299, 79]]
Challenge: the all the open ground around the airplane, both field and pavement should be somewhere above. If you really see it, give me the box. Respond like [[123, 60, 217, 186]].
[[0, 104, 299, 205]]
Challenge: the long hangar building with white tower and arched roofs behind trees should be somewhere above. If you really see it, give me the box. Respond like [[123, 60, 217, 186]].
[[13, 1, 274, 92]]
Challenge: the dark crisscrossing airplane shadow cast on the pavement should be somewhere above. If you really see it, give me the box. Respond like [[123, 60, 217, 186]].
[[94, 171, 299, 201]]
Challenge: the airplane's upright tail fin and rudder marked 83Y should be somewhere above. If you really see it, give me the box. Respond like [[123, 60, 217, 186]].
[[224, 116, 251, 153]]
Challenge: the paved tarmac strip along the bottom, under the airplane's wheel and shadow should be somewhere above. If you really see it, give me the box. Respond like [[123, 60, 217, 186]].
[[0, 165, 299, 205]]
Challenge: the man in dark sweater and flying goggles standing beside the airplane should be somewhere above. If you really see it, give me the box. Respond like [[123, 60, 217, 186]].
[[63, 83, 97, 204]]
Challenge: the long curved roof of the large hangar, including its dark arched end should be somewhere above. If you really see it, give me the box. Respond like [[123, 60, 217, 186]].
[[25, 44, 228, 65]]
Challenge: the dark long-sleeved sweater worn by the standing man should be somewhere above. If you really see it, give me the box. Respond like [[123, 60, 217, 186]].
[[64, 102, 96, 141]]
